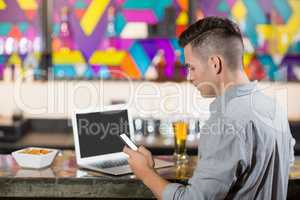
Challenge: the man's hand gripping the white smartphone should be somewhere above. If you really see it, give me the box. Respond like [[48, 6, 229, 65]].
[[123, 146, 154, 180]]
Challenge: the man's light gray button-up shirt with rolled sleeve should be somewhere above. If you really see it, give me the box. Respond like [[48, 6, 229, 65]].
[[163, 82, 294, 200]]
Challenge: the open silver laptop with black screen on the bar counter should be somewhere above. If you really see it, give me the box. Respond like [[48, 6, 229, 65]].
[[72, 104, 174, 175]]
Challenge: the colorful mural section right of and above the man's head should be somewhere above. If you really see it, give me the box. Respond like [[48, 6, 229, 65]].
[[196, 0, 300, 81]]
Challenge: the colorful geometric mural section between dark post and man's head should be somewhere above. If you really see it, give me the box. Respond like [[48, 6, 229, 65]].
[[52, 0, 188, 79]]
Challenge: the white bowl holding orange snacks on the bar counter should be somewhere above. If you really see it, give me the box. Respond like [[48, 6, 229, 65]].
[[12, 147, 58, 169]]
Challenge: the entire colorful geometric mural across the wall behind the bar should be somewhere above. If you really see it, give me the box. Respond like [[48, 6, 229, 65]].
[[0, 0, 300, 81]]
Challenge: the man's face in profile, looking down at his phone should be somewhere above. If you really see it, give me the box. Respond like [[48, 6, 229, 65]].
[[184, 44, 216, 97]]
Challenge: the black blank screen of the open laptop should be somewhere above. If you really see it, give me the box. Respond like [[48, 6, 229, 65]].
[[76, 110, 130, 158]]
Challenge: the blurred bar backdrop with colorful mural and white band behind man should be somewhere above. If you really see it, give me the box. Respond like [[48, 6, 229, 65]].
[[0, 0, 300, 154]]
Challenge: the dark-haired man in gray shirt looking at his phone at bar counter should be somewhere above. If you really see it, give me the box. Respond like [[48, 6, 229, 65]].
[[124, 17, 293, 200]]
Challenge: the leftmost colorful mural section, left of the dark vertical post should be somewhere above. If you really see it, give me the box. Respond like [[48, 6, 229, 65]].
[[0, 0, 41, 79]]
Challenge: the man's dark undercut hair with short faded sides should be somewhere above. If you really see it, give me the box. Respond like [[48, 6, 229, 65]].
[[179, 17, 244, 71]]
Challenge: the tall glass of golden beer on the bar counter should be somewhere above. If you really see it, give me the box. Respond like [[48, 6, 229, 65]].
[[172, 120, 188, 164]]
